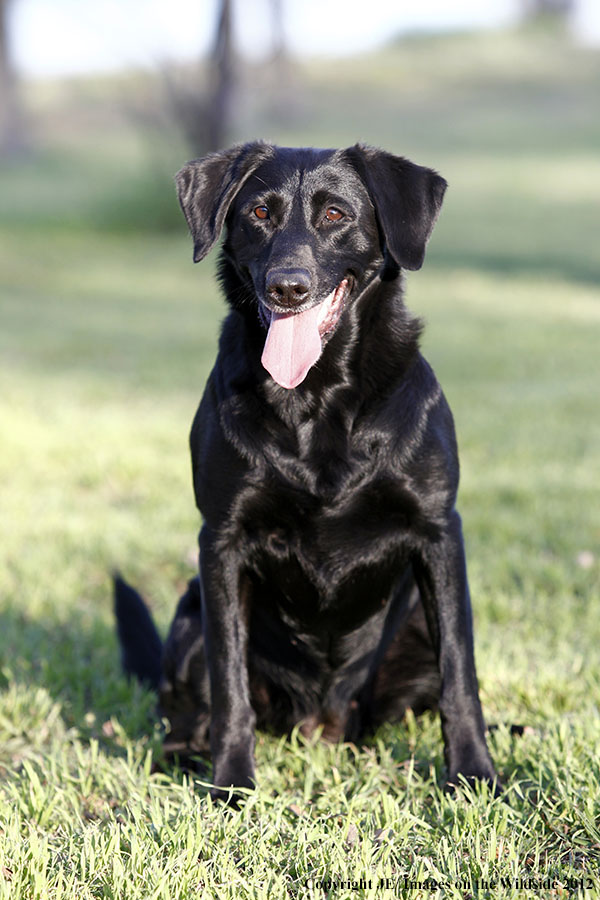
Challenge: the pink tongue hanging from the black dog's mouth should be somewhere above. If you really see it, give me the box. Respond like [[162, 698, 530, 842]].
[[261, 304, 321, 388]]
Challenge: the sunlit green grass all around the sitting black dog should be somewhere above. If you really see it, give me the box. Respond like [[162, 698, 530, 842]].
[[0, 24, 600, 900]]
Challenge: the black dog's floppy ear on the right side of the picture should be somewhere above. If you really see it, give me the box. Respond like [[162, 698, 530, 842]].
[[346, 144, 447, 269]]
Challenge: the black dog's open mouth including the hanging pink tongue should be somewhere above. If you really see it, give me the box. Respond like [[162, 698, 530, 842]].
[[260, 276, 352, 389]]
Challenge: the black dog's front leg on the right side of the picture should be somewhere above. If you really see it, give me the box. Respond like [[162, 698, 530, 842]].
[[415, 512, 497, 784]]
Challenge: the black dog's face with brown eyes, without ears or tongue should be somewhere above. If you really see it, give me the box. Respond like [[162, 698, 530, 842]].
[[225, 149, 380, 326]]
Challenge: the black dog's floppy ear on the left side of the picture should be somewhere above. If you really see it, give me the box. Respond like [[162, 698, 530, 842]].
[[175, 141, 273, 262]]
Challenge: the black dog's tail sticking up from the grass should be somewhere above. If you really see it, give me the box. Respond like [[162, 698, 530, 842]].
[[113, 572, 162, 691]]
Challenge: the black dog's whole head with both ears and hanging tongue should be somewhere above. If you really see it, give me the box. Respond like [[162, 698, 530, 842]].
[[176, 142, 446, 388]]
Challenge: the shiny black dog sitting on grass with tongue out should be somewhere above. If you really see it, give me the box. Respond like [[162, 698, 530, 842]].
[[117, 143, 496, 802]]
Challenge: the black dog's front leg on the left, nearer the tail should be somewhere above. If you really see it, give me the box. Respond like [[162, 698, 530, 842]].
[[200, 527, 255, 806]]
